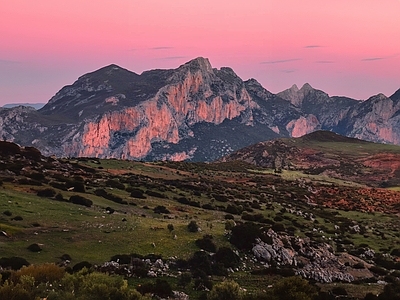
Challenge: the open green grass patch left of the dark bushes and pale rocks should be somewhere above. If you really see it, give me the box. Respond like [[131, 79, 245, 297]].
[[0, 189, 228, 263]]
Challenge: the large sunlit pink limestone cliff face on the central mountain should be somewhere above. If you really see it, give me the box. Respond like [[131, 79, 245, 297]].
[[65, 59, 252, 160]]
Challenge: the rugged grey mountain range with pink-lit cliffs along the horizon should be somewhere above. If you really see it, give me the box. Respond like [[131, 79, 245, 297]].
[[0, 57, 400, 161]]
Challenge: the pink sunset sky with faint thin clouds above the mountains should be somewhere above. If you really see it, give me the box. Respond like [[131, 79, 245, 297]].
[[0, 0, 400, 106]]
